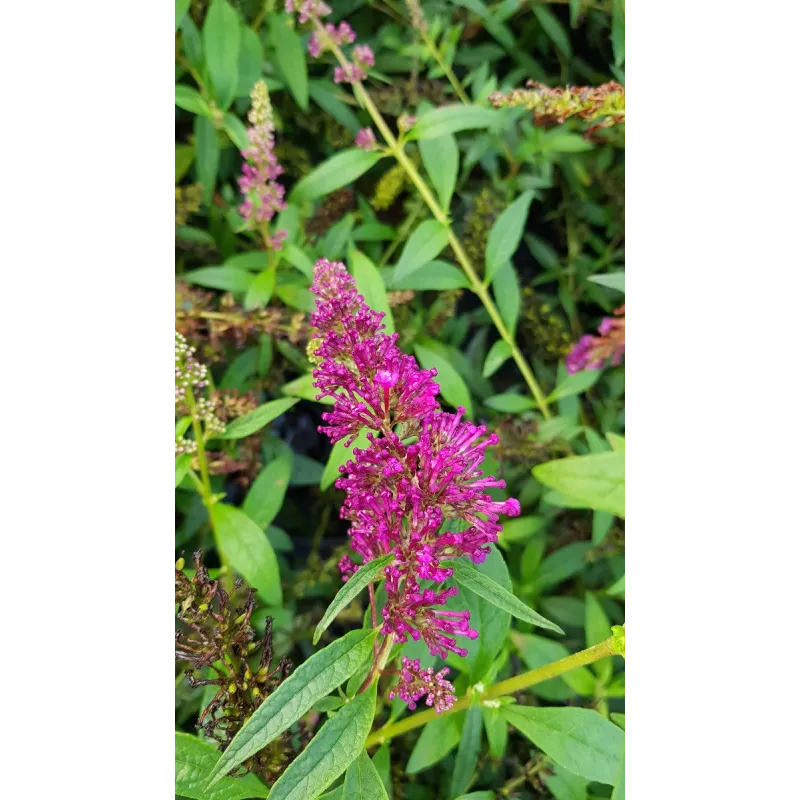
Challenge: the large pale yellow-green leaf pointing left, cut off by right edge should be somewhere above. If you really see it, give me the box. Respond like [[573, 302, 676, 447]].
[[533, 448, 627, 519]]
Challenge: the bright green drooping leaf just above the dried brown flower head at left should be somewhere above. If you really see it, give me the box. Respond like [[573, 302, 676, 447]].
[[210, 503, 283, 606]]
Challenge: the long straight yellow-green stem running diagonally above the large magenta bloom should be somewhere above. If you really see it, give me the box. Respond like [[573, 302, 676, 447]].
[[313, 17, 551, 419]]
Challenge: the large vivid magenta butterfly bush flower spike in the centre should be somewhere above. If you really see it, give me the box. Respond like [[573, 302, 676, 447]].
[[310, 259, 520, 711]]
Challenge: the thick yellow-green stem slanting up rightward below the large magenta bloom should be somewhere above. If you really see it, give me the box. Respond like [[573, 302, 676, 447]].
[[365, 636, 619, 747]]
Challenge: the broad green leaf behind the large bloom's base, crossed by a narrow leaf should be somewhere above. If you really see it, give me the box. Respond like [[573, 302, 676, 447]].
[[447, 544, 512, 683]]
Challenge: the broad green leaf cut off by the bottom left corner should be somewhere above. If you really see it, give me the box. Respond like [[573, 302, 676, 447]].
[[174, 731, 269, 800]]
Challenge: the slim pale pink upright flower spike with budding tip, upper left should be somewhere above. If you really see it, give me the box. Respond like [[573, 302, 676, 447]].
[[239, 81, 286, 250]]
